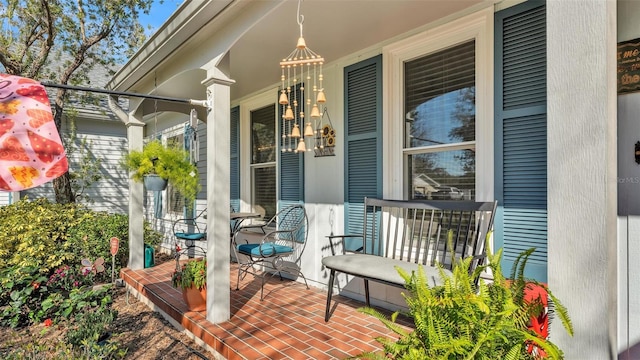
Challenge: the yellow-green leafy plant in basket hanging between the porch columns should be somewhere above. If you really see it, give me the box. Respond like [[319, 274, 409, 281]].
[[123, 140, 200, 204]]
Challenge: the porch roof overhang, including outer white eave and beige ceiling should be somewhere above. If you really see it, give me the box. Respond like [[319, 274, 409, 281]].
[[108, 0, 490, 108]]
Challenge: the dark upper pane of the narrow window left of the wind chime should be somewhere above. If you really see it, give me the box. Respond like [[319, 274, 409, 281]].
[[251, 105, 276, 164]]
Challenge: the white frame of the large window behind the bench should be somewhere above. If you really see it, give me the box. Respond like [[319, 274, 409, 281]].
[[382, 8, 494, 201]]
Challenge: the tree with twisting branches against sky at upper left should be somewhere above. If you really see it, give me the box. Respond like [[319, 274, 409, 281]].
[[0, 0, 152, 203]]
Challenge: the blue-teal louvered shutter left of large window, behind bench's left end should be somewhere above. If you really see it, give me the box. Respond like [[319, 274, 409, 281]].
[[344, 55, 382, 252]]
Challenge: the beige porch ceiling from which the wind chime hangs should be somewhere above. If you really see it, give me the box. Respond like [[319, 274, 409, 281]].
[[230, 0, 482, 99]]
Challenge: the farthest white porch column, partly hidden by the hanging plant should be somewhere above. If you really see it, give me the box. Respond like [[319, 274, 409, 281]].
[[127, 119, 144, 270]]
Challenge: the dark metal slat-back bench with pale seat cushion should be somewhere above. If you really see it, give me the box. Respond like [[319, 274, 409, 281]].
[[322, 198, 497, 321]]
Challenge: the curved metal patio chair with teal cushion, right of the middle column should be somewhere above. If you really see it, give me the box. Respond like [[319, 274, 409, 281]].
[[233, 204, 309, 300]]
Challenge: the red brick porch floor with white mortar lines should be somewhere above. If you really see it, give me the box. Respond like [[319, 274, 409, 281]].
[[121, 261, 410, 360]]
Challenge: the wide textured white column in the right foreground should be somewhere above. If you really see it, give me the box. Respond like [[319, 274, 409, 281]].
[[546, 0, 617, 359]]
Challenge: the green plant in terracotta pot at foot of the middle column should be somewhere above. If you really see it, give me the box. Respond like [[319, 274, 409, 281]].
[[171, 258, 207, 311]]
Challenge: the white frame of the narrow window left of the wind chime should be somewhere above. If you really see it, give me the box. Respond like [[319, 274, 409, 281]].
[[238, 88, 280, 211]]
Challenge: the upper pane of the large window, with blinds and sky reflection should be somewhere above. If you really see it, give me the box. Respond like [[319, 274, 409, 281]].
[[404, 41, 475, 148]]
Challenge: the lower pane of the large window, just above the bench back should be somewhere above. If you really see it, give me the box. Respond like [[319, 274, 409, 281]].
[[407, 150, 476, 200]]
